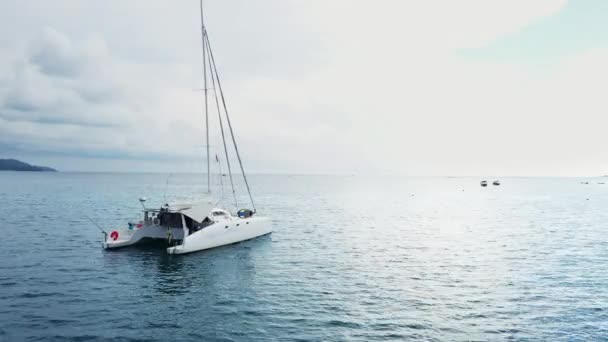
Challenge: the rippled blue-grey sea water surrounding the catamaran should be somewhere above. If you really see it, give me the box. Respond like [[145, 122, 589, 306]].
[[0, 172, 608, 341]]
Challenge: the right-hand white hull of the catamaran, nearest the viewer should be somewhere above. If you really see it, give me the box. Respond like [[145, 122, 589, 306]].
[[167, 217, 272, 254]]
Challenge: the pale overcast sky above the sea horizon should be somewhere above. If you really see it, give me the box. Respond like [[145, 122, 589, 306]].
[[0, 0, 608, 176]]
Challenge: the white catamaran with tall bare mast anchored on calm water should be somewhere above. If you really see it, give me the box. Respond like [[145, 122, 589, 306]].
[[103, 0, 272, 254]]
